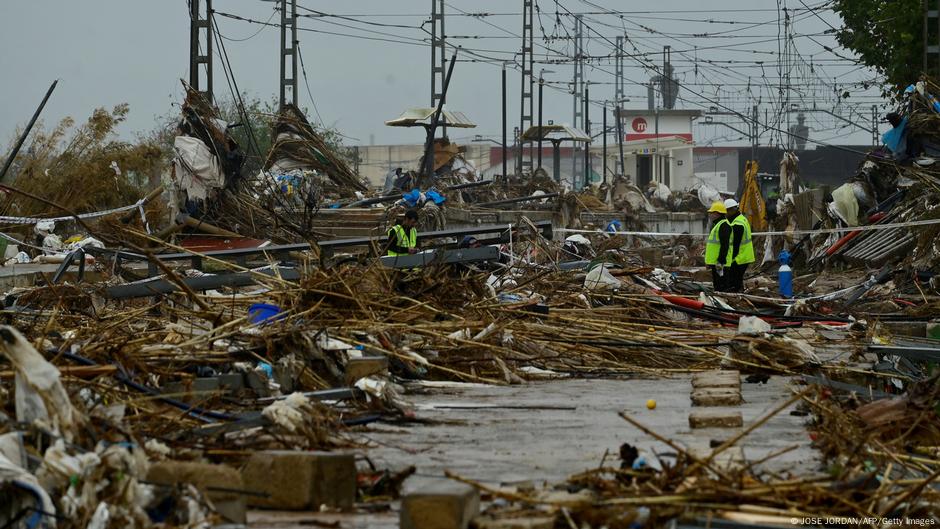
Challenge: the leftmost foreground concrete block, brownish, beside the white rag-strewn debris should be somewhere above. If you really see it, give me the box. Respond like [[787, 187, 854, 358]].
[[147, 461, 247, 524]]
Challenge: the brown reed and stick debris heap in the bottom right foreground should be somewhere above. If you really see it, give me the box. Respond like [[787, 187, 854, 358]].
[[457, 384, 940, 527]]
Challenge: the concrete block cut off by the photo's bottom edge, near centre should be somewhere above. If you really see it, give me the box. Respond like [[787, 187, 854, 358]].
[[399, 481, 480, 529]]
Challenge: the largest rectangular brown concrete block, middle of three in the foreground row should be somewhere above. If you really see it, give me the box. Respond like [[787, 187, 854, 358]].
[[242, 450, 356, 510]]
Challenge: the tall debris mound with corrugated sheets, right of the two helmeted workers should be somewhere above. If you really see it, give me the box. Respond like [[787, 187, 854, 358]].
[[776, 78, 940, 281]]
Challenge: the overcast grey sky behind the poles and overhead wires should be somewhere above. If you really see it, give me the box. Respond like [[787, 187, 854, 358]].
[[0, 0, 884, 150]]
